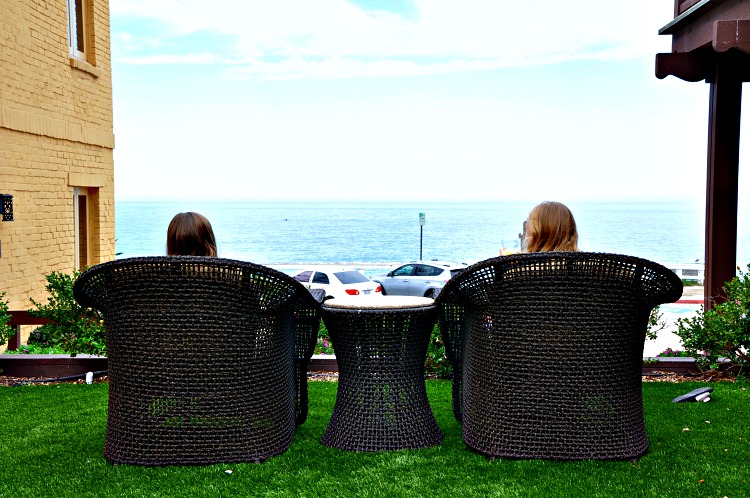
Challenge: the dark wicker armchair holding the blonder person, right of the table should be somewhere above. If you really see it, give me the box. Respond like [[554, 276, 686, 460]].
[[437, 252, 682, 460]]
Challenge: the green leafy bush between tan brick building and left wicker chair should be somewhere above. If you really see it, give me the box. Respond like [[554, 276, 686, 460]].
[[29, 271, 106, 356]]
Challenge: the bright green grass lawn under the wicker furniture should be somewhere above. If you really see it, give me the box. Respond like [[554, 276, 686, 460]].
[[0, 381, 750, 498]]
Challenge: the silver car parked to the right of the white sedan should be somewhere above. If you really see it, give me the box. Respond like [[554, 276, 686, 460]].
[[372, 261, 466, 297]]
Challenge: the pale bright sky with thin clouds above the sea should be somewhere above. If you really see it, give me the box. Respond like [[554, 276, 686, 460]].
[[110, 0, 750, 203]]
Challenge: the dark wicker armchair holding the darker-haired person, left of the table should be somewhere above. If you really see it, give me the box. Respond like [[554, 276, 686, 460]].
[[74, 256, 323, 465]]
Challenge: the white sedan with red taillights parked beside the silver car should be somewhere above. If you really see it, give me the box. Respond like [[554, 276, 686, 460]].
[[294, 267, 383, 299]]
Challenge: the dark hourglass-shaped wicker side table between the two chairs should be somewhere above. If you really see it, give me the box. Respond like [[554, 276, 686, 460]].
[[321, 296, 443, 451]]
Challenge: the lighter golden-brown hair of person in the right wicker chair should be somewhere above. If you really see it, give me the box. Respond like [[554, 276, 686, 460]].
[[526, 201, 578, 252]]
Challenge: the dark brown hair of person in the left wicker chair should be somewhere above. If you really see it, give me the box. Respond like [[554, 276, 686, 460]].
[[167, 212, 216, 256]]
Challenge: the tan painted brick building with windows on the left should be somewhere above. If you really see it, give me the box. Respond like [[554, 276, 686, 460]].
[[0, 0, 115, 348]]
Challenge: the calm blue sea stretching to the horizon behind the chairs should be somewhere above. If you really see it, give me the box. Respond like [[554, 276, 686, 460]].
[[116, 201, 750, 274]]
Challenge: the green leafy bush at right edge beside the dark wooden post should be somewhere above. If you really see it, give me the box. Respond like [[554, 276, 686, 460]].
[[676, 265, 750, 373]]
